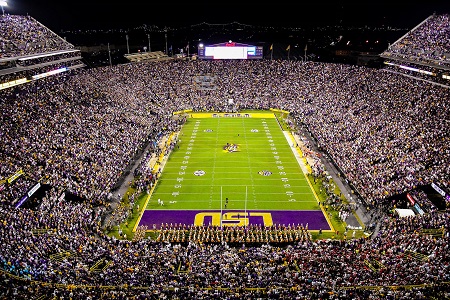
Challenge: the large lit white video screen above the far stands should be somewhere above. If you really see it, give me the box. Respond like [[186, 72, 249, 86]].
[[198, 42, 263, 59]]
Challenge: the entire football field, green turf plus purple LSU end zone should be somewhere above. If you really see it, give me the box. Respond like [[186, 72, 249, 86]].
[[138, 112, 330, 230]]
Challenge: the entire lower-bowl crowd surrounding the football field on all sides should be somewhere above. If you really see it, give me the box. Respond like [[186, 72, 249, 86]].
[[0, 10, 450, 299]]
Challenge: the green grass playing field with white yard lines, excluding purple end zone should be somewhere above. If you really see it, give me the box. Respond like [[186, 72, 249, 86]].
[[142, 112, 326, 226]]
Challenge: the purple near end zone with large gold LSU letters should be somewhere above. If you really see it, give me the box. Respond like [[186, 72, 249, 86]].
[[139, 210, 331, 230]]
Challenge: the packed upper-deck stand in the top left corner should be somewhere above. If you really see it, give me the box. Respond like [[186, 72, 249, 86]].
[[0, 14, 85, 89]]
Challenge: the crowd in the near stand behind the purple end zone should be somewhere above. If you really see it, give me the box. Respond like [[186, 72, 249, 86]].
[[0, 189, 450, 299]]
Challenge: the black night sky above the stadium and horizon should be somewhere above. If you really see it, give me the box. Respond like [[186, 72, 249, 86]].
[[5, 0, 450, 31]]
